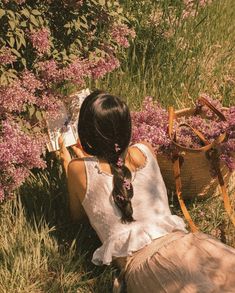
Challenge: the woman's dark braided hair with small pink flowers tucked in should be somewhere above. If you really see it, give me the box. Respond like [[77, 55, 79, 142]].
[[78, 91, 134, 223]]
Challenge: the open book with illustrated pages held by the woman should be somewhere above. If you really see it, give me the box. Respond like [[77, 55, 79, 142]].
[[47, 88, 90, 152]]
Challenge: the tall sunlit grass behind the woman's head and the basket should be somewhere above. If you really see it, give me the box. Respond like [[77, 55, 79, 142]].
[[98, 0, 235, 108]]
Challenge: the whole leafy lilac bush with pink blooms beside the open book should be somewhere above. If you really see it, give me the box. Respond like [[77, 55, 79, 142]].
[[0, 0, 134, 201]]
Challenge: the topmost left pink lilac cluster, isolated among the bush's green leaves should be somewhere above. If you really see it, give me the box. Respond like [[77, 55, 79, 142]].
[[28, 27, 50, 54]]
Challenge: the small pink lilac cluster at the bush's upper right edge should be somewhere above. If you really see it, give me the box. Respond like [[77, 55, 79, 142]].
[[111, 24, 136, 48]]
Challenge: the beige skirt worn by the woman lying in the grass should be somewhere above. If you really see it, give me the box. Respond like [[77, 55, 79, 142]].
[[125, 231, 235, 293]]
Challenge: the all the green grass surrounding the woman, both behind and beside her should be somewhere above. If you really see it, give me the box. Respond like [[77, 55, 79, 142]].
[[0, 0, 235, 293]]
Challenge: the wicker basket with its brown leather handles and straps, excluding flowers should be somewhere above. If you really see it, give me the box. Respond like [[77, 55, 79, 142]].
[[155, 98, 235, 232]]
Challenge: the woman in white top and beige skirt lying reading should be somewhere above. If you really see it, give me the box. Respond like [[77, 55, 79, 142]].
[[60, 91, 235, 293]]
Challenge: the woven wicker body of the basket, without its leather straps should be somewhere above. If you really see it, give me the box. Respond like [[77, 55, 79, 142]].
[[157, 108, 235, 198]]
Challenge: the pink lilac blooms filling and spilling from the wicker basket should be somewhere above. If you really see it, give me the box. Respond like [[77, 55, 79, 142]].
[[132, 95, 235, 171]]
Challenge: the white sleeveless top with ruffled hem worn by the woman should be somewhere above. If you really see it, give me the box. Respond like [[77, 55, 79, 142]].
[[82, 143, 187, 265]]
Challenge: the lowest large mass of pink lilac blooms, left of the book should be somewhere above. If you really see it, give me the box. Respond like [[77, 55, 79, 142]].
[[0, 118, 45, 200]]
